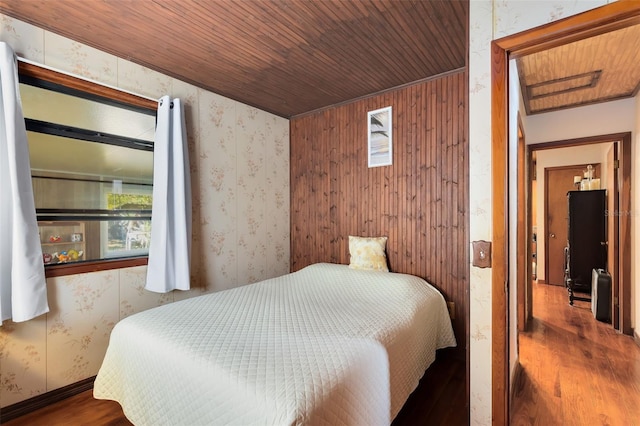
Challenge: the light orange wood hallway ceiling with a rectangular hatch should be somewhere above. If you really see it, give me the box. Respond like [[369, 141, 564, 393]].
[[516, 21, 640, 115]]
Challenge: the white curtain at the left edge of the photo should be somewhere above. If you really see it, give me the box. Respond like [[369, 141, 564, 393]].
[[0, 42, 49, 322]]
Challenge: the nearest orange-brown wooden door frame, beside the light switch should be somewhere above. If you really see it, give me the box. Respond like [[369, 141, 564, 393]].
[[490, 1, 640, 425]]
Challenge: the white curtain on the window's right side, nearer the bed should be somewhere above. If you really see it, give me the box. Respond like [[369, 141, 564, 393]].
[[145, 96, 191, 293]]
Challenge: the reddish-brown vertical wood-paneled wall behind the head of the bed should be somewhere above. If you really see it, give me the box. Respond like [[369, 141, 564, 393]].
[[290, 71, 469, 353]]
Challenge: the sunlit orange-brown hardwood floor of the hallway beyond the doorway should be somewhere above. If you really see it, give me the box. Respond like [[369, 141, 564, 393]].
[[511, 283, 640, 426]]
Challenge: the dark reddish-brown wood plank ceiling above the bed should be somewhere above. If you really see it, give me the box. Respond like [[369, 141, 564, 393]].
[[0, 0, 469, 118]]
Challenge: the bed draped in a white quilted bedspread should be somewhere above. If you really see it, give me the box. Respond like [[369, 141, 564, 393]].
[[94, 263, 456, 425]]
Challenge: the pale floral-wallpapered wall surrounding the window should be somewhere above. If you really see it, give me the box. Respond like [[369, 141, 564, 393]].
[[0, 14, 289, 407]]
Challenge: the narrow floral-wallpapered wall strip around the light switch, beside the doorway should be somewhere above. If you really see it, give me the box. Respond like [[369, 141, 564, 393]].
[[469, 0, 608, 425]]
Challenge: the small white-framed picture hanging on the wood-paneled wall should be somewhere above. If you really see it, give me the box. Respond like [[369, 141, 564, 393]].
[[367, 106, 393, 167]]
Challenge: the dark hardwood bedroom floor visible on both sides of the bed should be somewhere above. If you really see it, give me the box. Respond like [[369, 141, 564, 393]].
[[3, 354, 469, 426]]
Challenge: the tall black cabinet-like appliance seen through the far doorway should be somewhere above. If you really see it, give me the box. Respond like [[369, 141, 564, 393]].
[[565, 189, 607, 302]]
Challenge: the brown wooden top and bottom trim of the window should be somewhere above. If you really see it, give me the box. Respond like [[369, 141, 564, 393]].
[[18, 60, 158, 278]]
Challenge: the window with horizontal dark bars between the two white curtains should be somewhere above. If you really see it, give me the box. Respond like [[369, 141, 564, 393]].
[[20, 63, 156, 275]]
